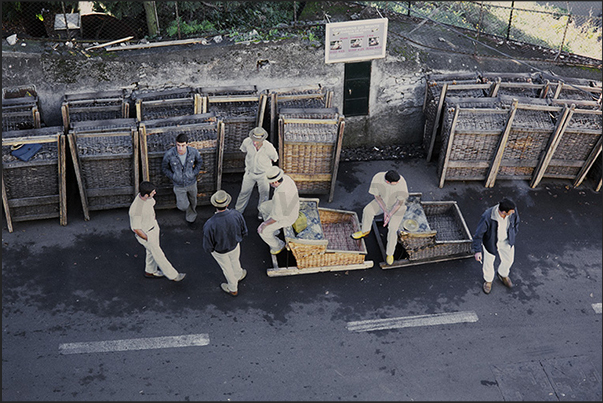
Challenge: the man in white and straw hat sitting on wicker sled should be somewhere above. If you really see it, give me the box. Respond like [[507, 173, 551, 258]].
[[258, 166, 299, 255]]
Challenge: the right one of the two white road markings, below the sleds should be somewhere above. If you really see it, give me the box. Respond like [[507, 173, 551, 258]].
[[347, 311, 477, 332]]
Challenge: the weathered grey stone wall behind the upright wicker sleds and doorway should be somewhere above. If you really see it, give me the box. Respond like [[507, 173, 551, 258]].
[[2, 40, 425, 147]]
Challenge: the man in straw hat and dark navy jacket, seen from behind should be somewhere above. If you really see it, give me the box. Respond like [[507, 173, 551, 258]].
[[203, 190, 247, 297]]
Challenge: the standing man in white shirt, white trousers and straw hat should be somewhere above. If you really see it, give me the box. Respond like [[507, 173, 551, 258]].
[[235, 127, 278, 220]]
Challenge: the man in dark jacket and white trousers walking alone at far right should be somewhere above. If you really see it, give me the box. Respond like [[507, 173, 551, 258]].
[[471, 198, 519, 294]]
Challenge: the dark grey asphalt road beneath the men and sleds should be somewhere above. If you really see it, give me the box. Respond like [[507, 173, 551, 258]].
[[2, 159, 602, 401]]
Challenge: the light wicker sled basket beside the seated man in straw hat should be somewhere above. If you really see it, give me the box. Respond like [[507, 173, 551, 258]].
[[284, 198, 367, 269]]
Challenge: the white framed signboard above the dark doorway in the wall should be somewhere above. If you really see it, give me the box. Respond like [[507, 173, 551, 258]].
[[325, 18, 387, 63]]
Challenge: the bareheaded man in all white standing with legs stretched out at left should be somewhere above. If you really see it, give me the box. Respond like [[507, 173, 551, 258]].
[[128, 181, 186, 281]]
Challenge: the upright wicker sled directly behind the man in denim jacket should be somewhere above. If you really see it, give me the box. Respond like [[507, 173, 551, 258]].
[[139, 113, 224, 208]]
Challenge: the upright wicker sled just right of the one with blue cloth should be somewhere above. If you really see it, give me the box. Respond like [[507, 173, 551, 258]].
[[68, 119, 139, 220]]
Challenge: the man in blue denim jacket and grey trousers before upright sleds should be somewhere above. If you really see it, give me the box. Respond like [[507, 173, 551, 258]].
[[161, 133, 203, 229]]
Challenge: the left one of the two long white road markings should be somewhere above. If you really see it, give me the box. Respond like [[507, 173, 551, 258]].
[[59, 334, 209, 354]]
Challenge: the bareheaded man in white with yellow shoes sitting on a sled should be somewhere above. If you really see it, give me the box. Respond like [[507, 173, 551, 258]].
[[352, 170, 408, 265]]
